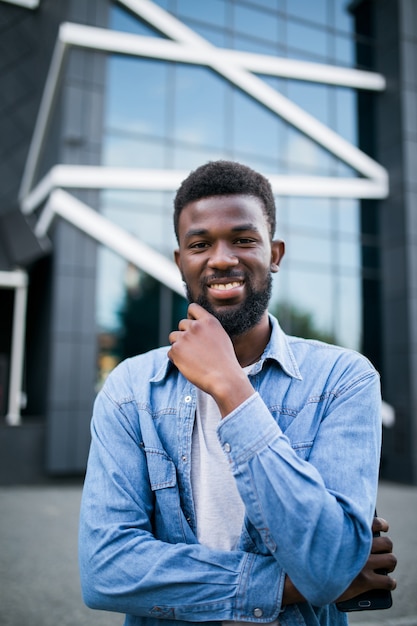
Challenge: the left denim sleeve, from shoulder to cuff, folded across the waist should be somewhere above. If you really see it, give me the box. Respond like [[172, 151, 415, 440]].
[[79, 364, 285, 622]]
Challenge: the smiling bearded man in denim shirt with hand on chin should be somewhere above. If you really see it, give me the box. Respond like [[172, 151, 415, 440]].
[[80, 161, 395, 626]]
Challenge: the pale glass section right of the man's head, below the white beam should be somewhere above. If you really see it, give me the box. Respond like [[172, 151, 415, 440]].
[[272, 193, 362, 350]]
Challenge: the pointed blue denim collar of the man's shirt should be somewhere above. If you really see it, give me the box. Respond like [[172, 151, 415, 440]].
[[151, 314, 303, 383]]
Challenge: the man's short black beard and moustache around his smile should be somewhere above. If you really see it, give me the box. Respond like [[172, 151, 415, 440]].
[[186, 272, 272, 338]]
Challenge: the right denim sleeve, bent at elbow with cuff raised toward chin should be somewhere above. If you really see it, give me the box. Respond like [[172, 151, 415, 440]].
[[218, 359, 381, 606]]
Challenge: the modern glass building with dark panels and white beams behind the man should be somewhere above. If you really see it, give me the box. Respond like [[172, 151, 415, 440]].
[[0, 0, 417, 482]]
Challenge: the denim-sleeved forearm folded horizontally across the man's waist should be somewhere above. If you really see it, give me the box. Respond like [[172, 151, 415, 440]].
[[80, 508, 280, 622]]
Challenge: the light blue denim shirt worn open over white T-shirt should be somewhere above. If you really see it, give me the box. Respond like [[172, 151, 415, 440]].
[[79, 317, 381, 626]]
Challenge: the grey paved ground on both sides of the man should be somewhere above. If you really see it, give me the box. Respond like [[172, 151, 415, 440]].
[[0, 483, 417, 626]]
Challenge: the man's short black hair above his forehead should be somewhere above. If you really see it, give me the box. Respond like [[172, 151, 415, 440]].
[[174, 160, 275, 241]]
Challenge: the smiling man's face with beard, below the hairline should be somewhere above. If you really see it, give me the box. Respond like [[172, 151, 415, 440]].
[[175, 195, 284, 337]]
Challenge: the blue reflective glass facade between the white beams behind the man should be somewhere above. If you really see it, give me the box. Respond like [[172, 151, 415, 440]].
[[97, 0, 380, 380]]
